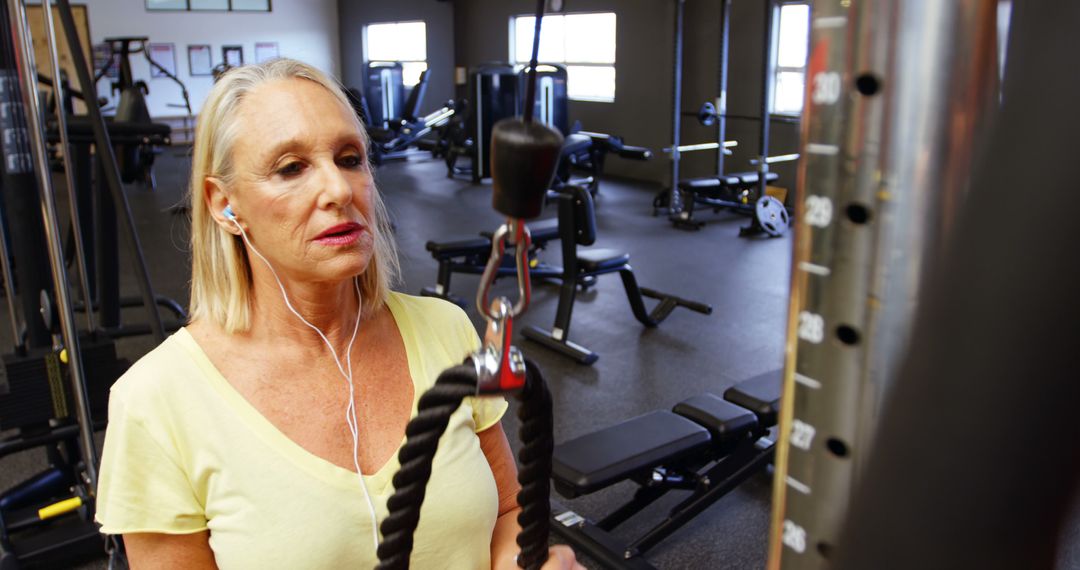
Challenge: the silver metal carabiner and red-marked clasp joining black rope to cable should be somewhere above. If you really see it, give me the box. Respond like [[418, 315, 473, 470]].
[[472, 215, 532, 394]]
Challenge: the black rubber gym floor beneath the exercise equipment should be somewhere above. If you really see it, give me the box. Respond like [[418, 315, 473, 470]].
[[0, 149, 1080, 569]]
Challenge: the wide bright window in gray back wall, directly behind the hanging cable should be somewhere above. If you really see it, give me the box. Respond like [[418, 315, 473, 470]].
[[510, 12, 616, 103]]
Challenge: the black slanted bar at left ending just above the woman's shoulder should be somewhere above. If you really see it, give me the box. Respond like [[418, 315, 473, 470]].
[[56, 0, 165, 342]]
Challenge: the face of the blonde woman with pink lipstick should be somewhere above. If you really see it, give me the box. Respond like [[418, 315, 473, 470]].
[[229, 79, 377, 282]]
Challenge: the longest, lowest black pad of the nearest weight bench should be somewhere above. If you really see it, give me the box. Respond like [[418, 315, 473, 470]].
[[552, 410, 710, 498]]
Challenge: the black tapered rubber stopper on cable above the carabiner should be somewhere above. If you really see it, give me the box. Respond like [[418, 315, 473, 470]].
[[491, 118, 563, 219]]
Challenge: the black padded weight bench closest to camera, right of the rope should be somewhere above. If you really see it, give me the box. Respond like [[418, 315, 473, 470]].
[[551, 370, 782, 569]]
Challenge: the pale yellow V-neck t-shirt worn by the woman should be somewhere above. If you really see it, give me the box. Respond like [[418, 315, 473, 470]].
[[97, 294, 507, 570]]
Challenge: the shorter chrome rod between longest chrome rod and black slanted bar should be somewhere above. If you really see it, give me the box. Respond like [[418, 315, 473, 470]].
[[35, 0, 95, 330]]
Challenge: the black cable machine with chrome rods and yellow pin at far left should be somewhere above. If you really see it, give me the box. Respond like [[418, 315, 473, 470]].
[[0, 0, 185, 570]]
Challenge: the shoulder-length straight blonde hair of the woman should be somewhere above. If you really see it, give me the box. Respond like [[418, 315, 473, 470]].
[[189, 58, 400, 333]]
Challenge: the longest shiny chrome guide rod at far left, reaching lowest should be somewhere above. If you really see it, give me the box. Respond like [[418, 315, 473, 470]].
[[8, 0, 97, 489]]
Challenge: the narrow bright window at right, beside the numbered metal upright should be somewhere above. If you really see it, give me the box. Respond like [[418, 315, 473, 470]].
[[772, 2, 810, 116]]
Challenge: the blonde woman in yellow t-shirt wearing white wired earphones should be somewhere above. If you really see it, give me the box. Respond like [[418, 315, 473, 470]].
[[97, 59, 580, 569]]
